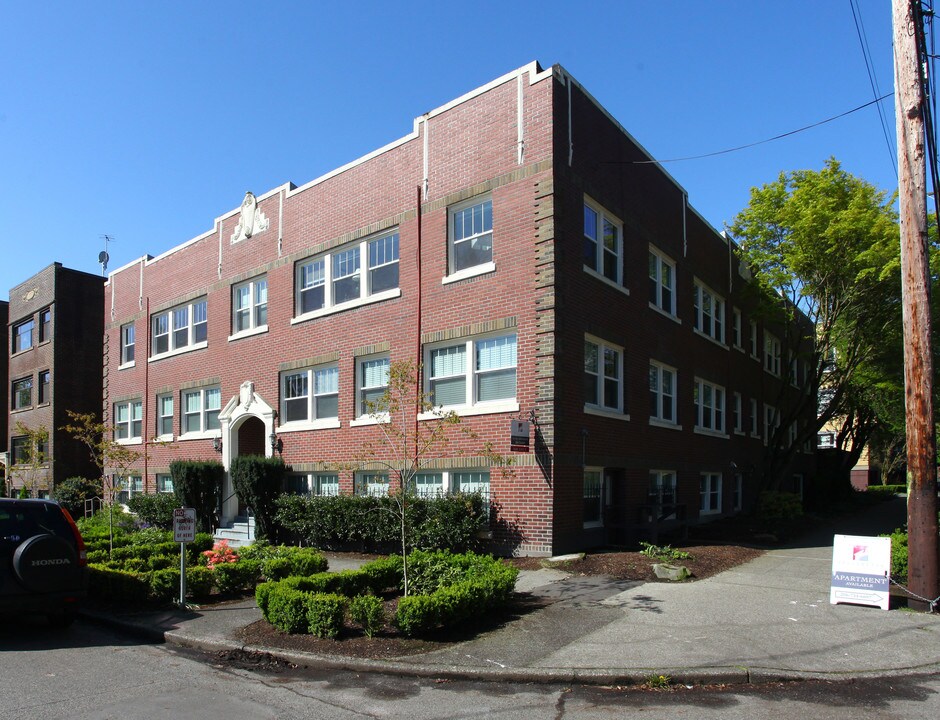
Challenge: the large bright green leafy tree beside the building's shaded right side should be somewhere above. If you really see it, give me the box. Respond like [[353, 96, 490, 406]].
[[730, 158, 901, 487]]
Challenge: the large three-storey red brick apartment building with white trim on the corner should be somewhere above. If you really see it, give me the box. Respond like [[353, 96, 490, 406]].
[[105, 63, 813, 554]]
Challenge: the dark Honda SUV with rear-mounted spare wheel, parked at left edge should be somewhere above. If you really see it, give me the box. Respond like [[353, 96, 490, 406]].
[[0, 498, 88, 626]]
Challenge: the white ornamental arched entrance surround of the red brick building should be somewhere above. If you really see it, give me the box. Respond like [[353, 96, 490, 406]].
[[219, 380, 277, 525]]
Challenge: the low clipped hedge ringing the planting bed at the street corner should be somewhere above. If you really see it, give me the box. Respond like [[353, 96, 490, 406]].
[[255, 551, 518, 637]]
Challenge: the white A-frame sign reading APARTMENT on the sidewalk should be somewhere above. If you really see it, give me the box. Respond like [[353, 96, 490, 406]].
[[829, 535, 891, 610]]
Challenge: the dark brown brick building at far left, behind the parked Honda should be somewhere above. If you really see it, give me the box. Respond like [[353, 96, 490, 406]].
[[2, 263, 104, 497]]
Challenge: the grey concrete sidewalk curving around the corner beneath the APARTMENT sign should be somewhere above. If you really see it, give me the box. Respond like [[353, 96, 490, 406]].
[[82, 498, 940, 684]]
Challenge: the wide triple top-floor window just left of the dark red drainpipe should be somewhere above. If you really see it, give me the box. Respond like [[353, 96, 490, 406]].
[[294, 231, 401, 320]]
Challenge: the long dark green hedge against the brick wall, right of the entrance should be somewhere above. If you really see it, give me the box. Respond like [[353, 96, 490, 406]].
[[275, 494, 489, 552]]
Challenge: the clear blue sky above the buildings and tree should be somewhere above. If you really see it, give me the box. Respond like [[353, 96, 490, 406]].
[[0, 0, 897, 299]]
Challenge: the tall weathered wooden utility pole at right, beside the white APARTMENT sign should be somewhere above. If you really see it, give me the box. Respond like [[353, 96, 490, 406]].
[[892, 0, 940, 612]]
